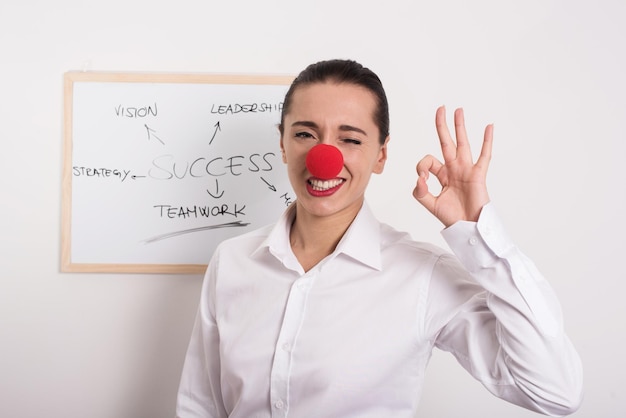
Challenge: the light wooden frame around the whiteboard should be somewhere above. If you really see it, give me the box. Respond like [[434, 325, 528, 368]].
[[61, 72, 294, 274]]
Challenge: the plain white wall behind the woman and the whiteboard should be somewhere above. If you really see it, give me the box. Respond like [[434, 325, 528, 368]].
[[0, 0, 626, 418]]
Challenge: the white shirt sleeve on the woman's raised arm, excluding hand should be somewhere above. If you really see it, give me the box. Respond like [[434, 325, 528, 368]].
[[428, 204, 582, 416]]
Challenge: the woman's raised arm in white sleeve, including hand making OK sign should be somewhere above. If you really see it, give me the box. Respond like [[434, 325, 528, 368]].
[[413, 107, 582, 415]]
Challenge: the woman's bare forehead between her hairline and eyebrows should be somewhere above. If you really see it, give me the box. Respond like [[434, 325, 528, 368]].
[[286, 82, 376, 124]]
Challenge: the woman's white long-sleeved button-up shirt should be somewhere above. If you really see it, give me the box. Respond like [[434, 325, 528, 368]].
[[177, 204, 582, 418]]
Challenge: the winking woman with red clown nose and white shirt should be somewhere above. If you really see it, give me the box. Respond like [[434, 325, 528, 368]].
[[177, 60, 582, 418]]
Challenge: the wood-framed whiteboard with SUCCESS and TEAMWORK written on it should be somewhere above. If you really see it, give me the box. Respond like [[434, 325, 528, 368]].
[[61, 72, 295, 273]]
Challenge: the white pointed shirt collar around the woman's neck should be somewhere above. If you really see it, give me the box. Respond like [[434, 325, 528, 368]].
[[253, 202, 382, 270]]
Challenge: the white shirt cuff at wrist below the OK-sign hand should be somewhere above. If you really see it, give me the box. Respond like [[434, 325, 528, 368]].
[[441, 202, 514, 272]]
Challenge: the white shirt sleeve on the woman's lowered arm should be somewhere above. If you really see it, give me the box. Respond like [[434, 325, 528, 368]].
[[176, 251, 227, 418]]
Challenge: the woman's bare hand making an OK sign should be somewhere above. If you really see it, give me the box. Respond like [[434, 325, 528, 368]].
[[413, 106, 493, 227]]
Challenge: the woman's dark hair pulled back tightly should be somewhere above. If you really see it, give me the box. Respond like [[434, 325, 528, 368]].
[[278, 59, 389, 145]]
